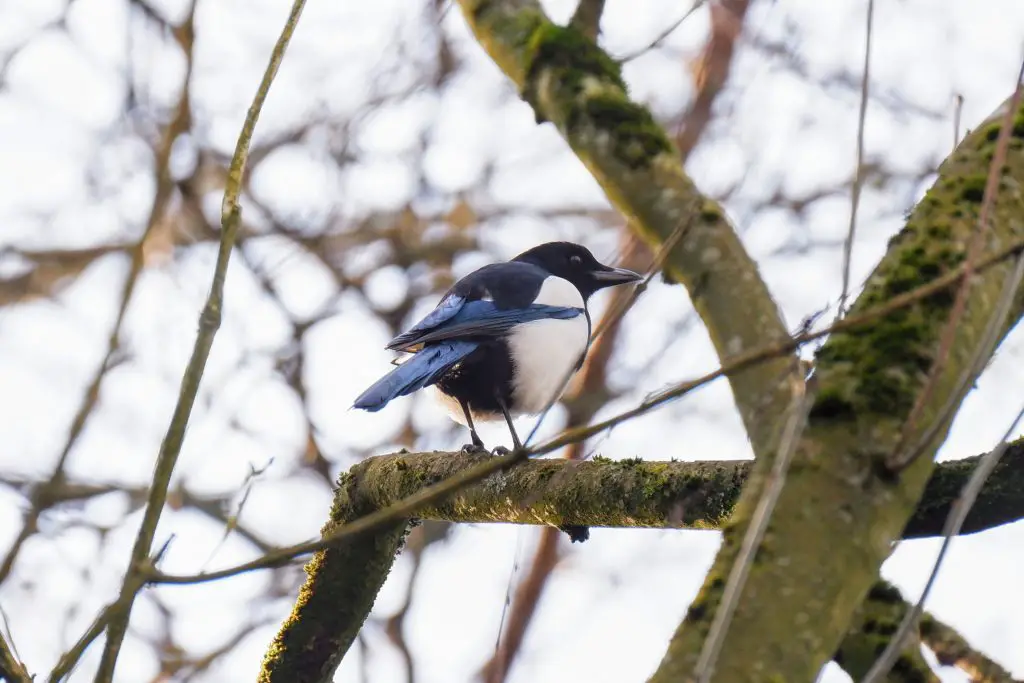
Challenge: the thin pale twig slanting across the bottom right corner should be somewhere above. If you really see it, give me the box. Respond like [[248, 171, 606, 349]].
[[863, 395, 1024, 683]]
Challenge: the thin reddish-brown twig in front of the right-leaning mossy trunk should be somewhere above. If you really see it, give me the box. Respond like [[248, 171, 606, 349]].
[[886, 60, 1024, 472]]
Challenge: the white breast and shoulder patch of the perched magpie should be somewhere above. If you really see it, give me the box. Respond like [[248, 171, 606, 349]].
[[508, 276, 589, 414]]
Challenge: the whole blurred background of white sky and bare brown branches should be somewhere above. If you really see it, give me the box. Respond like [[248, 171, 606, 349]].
[[0, 0, 1024, 683]]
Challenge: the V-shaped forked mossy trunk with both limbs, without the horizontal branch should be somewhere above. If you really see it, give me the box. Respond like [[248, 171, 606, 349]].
[[448, 0, 1024, 683]]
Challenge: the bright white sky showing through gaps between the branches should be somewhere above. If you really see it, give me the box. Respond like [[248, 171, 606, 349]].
[[0, 0, 1024, 683]]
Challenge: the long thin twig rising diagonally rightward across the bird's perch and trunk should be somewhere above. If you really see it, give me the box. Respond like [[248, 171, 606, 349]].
[[144, 231, 1024, 584]]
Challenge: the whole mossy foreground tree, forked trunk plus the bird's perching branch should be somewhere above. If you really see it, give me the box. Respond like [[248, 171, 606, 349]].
[[261, 0, 1024, 683]]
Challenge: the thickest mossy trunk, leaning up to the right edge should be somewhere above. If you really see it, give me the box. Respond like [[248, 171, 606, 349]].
[[651, 98, 1024, 683]]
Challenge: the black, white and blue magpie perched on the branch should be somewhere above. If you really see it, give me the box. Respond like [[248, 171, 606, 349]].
[[353, 242, 640, 453]]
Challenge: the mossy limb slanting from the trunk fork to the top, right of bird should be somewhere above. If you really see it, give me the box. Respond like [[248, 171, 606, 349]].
[[460, 0, 797, 457]]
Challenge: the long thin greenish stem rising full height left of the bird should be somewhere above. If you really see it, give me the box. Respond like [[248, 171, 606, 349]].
[[95, 0, 305, 683]]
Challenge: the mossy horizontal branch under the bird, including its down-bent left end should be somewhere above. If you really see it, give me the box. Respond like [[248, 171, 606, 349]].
[[260, 439, 1024, 683]]
